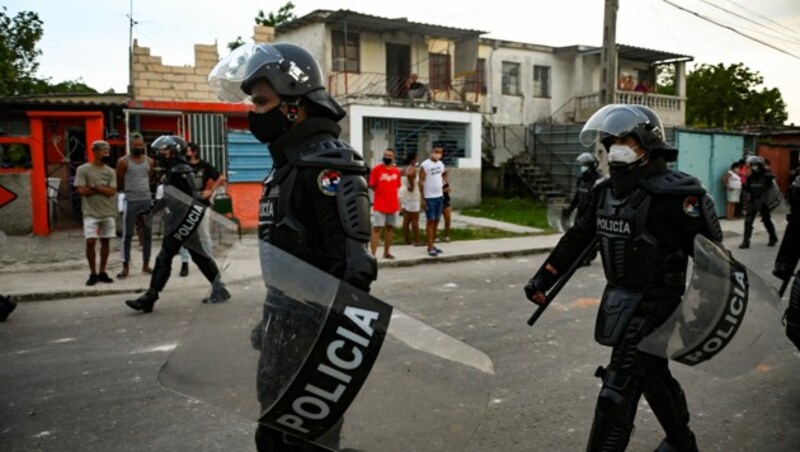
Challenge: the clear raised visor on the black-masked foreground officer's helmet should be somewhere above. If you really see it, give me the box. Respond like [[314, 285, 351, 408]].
[[208, 43, 283, 103]]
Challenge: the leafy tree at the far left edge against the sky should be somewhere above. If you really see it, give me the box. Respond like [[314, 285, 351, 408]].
[[0, 6, 97, 96]]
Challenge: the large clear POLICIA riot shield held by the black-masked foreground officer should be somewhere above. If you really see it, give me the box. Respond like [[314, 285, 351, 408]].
[[159, 242, 494, 451]]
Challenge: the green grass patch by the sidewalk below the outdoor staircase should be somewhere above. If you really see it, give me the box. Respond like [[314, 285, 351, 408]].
[[461, 196, 549, 229]]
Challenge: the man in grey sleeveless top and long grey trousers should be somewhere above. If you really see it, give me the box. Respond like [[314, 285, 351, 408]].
[[116, 133, 155, 278]]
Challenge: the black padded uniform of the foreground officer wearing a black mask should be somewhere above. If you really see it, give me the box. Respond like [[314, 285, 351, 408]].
[[252, 117, 377, 451]]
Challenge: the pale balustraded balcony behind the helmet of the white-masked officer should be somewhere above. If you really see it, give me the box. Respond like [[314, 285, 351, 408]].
[[574, 91, 686, 126]]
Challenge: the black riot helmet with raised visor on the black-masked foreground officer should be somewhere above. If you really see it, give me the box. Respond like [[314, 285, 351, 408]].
[[208, 42, 346, 121]]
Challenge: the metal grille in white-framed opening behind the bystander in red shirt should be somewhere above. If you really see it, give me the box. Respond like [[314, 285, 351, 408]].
[[364, 118, 467, 166]]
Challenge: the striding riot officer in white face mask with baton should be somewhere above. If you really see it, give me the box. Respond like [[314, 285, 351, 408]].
[[525, 104, 722, 452]]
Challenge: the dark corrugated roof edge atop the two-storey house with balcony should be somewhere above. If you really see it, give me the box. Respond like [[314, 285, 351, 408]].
[[275, 9, 487, 39]]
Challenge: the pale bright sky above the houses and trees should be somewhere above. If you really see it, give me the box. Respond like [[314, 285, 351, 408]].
[[6, 0, 800, 125]]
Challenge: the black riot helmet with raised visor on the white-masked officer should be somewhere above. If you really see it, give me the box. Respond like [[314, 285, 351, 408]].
[[580, 104, 678, 162]]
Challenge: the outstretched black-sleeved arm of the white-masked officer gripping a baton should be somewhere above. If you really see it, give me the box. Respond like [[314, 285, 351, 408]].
[[524, 189, 599, 303]]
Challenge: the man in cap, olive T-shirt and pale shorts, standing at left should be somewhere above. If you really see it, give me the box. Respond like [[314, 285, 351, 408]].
[[75, 140, 117, 286]]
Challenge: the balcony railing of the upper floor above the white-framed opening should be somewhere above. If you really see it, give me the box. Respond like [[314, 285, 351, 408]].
[[328, 72, 481, 104]]
